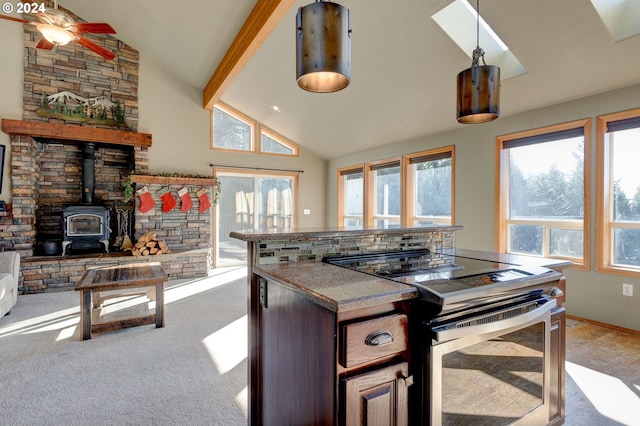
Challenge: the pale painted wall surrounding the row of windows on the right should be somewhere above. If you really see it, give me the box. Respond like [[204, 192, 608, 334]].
[[327, 85, 640, 330]]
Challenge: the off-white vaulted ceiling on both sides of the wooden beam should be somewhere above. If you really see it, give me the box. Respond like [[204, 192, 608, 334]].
[[43, 0, 640, 158]]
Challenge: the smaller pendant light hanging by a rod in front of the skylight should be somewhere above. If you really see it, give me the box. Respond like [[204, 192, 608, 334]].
[[457, 0, 500, 124]]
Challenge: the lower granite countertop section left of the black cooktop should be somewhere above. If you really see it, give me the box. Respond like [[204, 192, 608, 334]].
[[253, 262, 418, 313]]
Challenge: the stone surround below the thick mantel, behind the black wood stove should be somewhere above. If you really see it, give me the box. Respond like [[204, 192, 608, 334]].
[[0, 135, 149, 257]]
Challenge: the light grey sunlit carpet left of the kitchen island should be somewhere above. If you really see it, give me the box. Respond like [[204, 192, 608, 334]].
[[0, 267, 247, 426]]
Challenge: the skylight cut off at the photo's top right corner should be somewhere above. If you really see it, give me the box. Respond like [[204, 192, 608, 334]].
[[591, 0, 640, 42]]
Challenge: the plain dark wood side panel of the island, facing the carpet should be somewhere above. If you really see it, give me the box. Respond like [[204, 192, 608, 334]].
[[250, 277, 337, 426]]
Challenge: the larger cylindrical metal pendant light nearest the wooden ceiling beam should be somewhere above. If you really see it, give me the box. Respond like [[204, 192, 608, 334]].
[[296, 0, 351, 93]]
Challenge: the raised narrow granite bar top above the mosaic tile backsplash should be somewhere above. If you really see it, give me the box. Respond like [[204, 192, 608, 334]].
[[229, 225, 463, 241]]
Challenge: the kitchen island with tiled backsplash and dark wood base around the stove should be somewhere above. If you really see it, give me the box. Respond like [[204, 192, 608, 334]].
[[231, 226, 568, 425]]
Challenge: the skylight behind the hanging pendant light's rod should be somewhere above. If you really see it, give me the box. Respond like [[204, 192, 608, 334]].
[[431, 0, 527, 81]]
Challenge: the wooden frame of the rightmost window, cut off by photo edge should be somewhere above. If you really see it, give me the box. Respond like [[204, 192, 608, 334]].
[[596, 108, 640, 278]]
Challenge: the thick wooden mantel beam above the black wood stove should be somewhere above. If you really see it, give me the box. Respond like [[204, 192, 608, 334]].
[[2, 119, 151, 147]]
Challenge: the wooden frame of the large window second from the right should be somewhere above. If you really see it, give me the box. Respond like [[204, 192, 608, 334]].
[[495, 118, 591, 270]]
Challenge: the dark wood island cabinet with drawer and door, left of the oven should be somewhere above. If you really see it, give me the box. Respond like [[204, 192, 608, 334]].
[[249, 275, 411, 426]]
